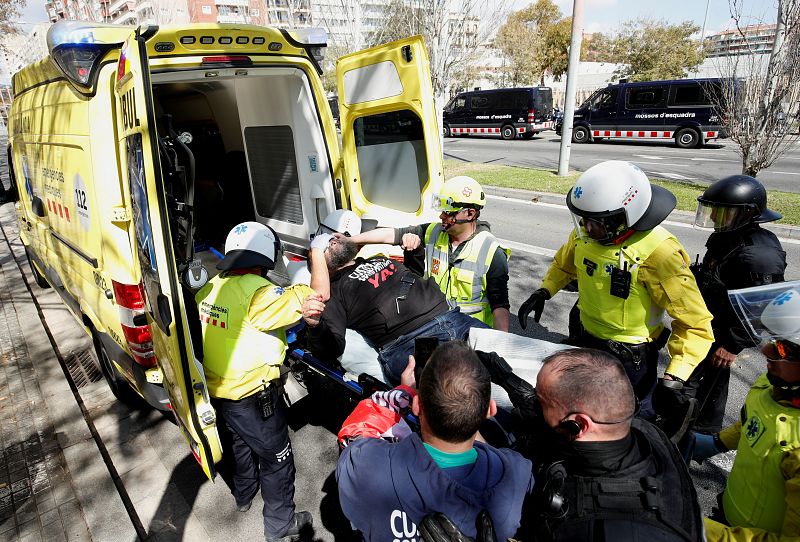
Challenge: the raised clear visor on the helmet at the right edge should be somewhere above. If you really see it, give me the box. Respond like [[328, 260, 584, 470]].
[[728, 281, 800, 350]]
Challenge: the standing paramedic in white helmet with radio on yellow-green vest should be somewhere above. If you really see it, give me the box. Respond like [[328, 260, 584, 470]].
[[518, 160, 714, 441]]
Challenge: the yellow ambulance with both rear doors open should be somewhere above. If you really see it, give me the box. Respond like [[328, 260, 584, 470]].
[[7, 22, 442, 478]]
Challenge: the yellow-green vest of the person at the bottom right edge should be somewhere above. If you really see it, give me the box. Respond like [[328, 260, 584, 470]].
[[722, 374, 800, 533]]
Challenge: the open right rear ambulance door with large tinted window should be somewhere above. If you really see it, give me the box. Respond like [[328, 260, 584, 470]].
[[336, 36, 443, 227]]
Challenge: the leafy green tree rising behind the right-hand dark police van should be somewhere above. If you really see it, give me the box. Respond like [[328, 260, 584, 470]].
[[613, 19, 705, 81]]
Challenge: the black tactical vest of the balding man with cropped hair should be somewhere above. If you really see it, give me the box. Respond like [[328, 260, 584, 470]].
[[537, 419, 704, 542]]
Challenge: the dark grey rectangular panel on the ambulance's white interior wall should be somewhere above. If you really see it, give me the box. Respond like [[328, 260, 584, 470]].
[[244, 126, 303, 224]]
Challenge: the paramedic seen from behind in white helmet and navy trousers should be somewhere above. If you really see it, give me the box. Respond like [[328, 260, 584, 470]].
[[195, 222, 331, 542]]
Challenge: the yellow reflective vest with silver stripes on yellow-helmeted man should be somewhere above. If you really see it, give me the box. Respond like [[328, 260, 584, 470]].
[[425, 223, 511, 326]]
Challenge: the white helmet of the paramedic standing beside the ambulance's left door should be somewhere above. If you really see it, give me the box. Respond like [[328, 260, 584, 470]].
[[217, 222, 281, 271]]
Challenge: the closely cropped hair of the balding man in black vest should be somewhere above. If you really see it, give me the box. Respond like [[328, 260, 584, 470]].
[[542, 348, 636, 420]]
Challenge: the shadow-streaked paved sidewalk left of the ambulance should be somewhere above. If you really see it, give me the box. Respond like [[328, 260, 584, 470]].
[[0, 204, 91, 541]]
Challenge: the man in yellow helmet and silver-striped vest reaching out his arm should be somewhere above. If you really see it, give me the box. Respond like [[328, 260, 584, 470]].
[[346, 175, 511, 331]]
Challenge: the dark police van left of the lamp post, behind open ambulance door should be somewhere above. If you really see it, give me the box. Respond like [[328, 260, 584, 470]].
[[442, 87, 553, 139]]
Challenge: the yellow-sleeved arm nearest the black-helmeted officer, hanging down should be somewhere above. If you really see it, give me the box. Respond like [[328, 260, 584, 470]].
[[639, 239, 714, 380]]
